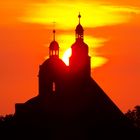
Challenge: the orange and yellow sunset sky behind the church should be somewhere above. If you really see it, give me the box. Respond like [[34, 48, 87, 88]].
[[0, 0, 140, 115]]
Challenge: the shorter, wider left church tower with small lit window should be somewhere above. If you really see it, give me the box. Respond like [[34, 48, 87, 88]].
[[39, 30, 66, 98]]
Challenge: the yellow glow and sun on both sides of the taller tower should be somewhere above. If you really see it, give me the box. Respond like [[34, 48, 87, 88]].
[[58, 34, 108, 68]]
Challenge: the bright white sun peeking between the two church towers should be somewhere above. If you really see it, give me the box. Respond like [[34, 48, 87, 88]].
[[62, 48, 72, 66]]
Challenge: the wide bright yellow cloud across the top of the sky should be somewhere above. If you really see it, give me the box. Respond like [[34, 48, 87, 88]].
[[20, 1, 140, 29]]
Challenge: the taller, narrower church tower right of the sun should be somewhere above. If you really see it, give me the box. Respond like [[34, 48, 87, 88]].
[[69, 13, 91, 81]]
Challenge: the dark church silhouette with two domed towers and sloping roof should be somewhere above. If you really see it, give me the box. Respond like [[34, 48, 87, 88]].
[[14, 14, 133, 140]]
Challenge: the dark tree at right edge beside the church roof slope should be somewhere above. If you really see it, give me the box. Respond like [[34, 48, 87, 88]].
[[125, 105, 140, 129]]
